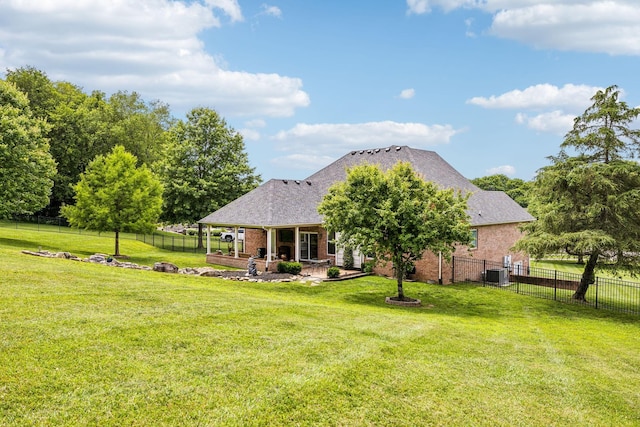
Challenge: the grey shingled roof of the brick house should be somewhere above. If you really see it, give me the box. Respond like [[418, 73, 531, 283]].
[[199, 146, 534, 228]]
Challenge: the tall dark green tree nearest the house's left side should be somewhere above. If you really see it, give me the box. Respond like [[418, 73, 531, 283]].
[[158, 108, 261, 247]]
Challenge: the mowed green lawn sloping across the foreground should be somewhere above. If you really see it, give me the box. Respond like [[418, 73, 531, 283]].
[[0, 228, 640, 426]]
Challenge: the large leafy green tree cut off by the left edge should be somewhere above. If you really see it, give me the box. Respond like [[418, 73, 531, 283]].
[[0, 80, 56, 218]]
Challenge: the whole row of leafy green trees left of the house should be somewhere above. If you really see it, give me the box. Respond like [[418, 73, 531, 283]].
[[0, 66, 261, 254]]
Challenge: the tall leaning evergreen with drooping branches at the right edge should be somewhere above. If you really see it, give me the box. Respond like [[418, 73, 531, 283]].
[[516, 86, 640, 301]]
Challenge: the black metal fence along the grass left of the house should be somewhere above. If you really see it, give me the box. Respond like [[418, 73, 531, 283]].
[[0, 215, 244, 254]]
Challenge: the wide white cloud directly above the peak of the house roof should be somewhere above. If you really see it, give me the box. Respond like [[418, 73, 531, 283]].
[[272, 121, 462, 169]]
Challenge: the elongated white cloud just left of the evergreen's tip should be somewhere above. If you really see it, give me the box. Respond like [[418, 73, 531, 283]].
[[467, 84, 603, 110]]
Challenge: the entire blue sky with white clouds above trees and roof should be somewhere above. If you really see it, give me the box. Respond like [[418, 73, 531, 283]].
[[0, 0, 640, 180]]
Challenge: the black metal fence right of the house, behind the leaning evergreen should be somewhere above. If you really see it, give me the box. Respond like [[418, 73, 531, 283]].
[[452, 257, 640, 314]]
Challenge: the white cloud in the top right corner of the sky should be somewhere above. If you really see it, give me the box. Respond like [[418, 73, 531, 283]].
[[407, 0, 640, 55]]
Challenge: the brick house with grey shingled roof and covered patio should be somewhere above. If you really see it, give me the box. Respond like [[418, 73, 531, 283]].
[[199, 146, 534, 283]]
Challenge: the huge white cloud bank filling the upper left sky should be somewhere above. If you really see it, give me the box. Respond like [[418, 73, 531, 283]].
[[0, 0, 309, 117]]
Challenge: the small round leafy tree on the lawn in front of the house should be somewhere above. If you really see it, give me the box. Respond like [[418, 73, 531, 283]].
[[318, 162, 471, 301]]
